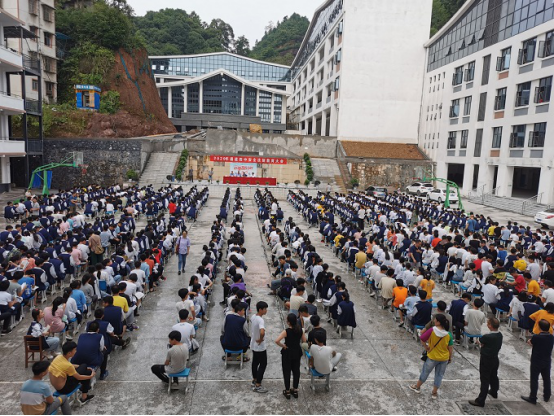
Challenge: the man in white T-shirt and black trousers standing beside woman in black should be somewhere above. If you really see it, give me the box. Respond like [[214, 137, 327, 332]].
[[250, 302, 269, 394]]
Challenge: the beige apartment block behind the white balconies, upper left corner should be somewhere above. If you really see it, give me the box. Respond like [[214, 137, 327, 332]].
[[2, 0, 58, 103]]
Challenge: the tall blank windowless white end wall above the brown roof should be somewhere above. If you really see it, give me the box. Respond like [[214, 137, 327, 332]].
[[338, 0, 432, 144]]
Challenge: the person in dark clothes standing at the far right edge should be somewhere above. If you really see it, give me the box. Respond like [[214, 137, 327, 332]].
[[521, 320, 554, 404]]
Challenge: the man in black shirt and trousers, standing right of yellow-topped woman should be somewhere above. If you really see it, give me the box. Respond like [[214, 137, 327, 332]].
[[469, 318, 504, 407]]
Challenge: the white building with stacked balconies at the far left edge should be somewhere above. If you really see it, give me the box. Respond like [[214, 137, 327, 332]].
[[0, 8, 25, 192]]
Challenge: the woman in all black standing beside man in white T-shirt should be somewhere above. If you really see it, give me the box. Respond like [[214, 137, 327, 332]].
[[275, 314, 306, 400]]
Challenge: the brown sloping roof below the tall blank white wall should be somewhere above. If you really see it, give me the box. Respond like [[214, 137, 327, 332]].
[[341, 141, 427, 160]]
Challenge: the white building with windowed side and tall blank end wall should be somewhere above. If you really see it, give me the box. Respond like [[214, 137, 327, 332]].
[[289, 0, 432, 144]]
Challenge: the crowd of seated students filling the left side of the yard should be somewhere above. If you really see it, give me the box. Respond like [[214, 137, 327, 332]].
[[13, 186, 209, 411]]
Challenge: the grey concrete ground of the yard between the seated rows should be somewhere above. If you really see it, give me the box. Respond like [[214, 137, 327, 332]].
[[0, 190, 554, 415]]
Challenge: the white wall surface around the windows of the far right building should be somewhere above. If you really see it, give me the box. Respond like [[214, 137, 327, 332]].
[[419, 21, 554, 204]]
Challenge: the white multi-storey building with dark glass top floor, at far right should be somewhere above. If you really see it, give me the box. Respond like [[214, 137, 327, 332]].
[[419, 0, 554, 204]]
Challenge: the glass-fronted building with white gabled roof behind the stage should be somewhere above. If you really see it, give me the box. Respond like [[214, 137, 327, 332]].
[[150, 52, 290, 133]]
